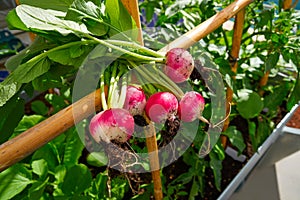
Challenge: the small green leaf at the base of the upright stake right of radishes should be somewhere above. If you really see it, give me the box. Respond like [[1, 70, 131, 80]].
[[222, 126, 246, 153]]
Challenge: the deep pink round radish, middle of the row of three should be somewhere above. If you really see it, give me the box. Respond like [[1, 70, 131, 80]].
[[145, 92, 178, 123]]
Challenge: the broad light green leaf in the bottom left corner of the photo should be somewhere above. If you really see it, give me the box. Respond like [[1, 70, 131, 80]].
[[0, 164, 33, 199]]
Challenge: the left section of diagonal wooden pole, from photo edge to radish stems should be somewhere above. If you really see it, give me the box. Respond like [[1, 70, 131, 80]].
[[0, 89, 101, 171]]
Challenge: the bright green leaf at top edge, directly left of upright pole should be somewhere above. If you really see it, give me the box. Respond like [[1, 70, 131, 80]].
[[105, 0, 136, 36]]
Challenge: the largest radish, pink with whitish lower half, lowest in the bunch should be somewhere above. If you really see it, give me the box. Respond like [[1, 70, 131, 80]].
[[89, 108, 134, 143]]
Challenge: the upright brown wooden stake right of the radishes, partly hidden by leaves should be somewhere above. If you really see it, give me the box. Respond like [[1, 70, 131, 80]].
[[221, 9, 245, 147]]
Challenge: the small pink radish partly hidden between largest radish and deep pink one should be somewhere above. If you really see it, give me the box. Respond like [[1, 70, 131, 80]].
[[124, 86, 146, 116]]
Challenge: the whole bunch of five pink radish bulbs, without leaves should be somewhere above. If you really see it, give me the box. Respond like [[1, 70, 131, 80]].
[[89, 48, 205, 143]]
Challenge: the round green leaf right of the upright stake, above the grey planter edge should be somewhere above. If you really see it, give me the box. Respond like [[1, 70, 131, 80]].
[[237, 90, 264, 119]]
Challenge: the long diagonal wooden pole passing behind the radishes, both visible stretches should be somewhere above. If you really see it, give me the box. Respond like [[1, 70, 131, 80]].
[[0, 0, 253, 171]]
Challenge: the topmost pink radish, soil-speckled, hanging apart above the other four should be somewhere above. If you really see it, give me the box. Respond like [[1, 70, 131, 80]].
[[164, 48, 194, 83]]
